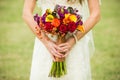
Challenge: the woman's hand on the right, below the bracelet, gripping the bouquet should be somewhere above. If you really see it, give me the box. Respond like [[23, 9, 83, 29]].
[[58, 37, 75, 57]]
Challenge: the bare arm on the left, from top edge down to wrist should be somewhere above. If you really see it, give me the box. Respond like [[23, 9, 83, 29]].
[[22, 0, 46, 42]]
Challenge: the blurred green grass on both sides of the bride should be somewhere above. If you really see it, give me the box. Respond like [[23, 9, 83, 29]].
[[0, 0, 120, 80]]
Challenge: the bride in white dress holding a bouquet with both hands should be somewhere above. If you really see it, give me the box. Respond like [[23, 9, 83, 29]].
[[23, 0, 100, 80]]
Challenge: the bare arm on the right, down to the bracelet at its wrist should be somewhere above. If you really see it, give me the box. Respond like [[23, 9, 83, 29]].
[[76, 0, 100, 40]]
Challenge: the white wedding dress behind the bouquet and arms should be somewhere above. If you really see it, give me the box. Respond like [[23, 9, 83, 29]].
[[30, 0, 99, 80]]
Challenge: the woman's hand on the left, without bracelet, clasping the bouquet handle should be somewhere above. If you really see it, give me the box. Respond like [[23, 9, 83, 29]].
[[44, 40, 63, 61]]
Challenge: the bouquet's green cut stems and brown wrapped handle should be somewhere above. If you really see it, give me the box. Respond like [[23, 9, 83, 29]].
[[49, 36, 67, 78]]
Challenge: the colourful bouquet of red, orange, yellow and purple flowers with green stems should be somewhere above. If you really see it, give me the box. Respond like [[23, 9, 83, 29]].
[[34, 5, 84, 78]]
